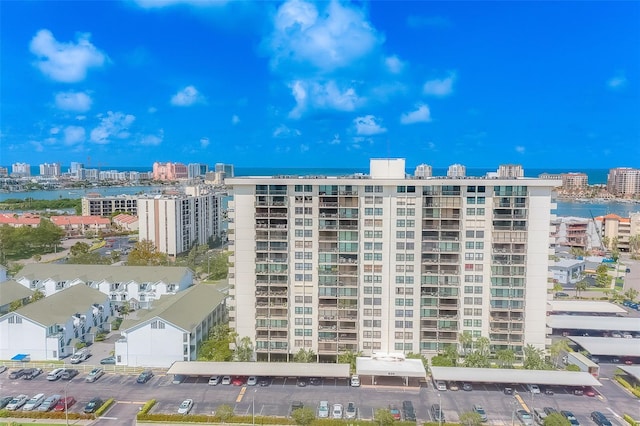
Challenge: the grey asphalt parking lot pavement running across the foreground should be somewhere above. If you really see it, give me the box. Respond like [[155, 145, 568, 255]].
[[0, 366, 640, 426]]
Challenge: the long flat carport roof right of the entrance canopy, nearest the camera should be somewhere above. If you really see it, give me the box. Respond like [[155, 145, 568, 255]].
[[431, 367, 601, 386]]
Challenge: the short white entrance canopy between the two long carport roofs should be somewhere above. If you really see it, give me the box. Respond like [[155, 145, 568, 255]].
[[356, 354, 427, 386]]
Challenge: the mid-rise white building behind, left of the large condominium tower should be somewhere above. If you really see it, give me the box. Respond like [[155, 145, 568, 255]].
[[138, 186, 222, 256]]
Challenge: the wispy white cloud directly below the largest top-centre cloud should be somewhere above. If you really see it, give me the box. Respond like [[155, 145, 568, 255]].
[[289, 80, 363, 118]]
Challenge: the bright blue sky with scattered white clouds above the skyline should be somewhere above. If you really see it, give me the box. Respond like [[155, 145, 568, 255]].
[[0, 0, 640, 171]]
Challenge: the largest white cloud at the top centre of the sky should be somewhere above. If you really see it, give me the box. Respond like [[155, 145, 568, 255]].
[[265, 0, 382, 71]]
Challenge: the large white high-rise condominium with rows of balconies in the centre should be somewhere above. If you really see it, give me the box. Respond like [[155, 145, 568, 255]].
[[227, 159, 560, 362]]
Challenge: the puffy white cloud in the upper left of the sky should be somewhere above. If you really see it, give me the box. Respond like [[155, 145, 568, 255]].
[[29, 30, 108, 83]]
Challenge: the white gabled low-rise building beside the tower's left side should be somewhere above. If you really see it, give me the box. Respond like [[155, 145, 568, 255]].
[[115, 284, 226, 367]]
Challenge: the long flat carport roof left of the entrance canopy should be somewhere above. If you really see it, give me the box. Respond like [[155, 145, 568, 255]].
[[167, 361, 349, 377]]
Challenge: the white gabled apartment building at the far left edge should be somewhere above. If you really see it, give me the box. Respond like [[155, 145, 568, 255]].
[[0, 286, 113, 361]]
